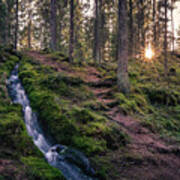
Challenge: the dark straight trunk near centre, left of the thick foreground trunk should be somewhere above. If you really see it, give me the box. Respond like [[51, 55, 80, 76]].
[[93, 0, 100, 63]]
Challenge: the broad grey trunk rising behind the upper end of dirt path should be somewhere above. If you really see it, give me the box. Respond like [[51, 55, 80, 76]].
[[50, 0, 57, 51]]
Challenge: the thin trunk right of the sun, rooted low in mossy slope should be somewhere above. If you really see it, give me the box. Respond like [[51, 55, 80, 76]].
[[164, 0, 168, 78]]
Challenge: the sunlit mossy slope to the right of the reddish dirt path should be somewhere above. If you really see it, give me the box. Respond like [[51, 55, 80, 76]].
[[101, 54, 180, 140]]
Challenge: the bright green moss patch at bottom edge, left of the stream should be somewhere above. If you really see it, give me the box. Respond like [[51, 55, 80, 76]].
[[21, 156, 65, 180]]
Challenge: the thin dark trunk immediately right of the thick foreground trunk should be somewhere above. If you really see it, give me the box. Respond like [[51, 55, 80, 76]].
[[129, 0, 134, 57]]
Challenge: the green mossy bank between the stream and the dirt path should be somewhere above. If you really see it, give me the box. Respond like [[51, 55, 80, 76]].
[[19, 52, 129, 179]]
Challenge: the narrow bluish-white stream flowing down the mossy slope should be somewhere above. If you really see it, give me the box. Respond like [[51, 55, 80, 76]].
[[8, 65, 94, 180]]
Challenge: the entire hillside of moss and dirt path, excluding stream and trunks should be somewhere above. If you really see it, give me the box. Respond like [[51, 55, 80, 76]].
[[0, 47, 180, 180]]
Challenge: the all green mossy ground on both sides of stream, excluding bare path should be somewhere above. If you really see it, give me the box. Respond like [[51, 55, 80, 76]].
[[0, 47, 180, 180]]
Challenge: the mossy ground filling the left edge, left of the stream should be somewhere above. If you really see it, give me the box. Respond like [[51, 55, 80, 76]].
[[0, 49, 64, 180]]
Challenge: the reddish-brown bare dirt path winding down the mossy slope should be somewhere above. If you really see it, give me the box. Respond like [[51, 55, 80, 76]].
[[25, 51, 180, 180]]
